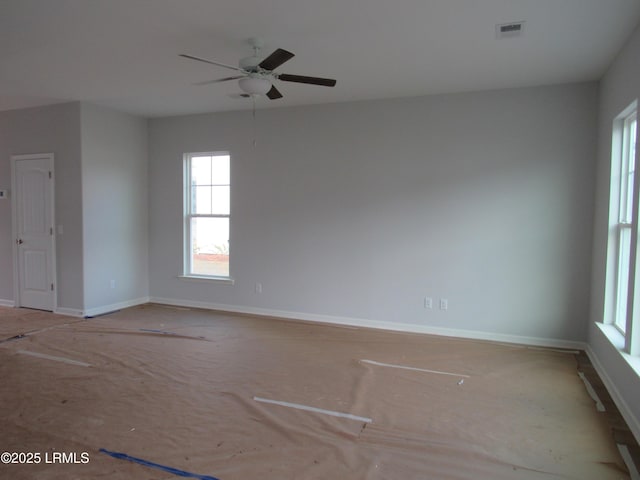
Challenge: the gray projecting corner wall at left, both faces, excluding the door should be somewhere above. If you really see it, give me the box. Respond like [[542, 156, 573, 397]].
[[0, 103, 148, 315]]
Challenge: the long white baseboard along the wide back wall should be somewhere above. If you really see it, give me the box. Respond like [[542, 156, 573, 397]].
[[149, 297, 585, 350]]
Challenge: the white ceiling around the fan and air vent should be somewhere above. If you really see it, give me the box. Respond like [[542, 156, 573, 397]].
[[0, 0, 640, 117]]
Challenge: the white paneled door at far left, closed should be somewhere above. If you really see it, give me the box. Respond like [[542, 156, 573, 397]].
[[11, 154, 56, 311]]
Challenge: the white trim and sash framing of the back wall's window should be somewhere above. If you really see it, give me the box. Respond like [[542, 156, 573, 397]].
[[178, 150, 235, 285]]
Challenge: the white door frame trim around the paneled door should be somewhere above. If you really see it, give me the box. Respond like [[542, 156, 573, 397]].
[[11, 153, 58, 312]]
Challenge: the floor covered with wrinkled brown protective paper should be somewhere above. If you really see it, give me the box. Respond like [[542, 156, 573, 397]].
[[0, 305, 630, 480]]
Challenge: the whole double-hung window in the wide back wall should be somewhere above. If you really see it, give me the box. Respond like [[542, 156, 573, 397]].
[[184, 152, 231, 279]]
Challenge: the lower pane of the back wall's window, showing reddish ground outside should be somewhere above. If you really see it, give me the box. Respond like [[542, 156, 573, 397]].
[[191, 218, 229, 277]]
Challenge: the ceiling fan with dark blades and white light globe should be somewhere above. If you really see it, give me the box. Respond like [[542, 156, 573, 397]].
[[180, 38, 336, 100]]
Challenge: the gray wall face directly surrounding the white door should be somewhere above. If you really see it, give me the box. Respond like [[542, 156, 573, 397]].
[[0, 103, 83, 311]]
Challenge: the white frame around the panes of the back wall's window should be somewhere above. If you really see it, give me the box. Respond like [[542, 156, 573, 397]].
[[179, 150, 234, 284]]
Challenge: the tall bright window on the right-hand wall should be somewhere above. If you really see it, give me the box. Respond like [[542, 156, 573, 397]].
[[607, 103, 640, 353]]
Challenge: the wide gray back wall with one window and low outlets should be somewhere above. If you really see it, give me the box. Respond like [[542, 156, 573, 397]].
[[149, 83, 597, 340]]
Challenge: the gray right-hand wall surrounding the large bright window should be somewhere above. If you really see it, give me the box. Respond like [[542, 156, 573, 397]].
[[589, 27, 640, 435]]
